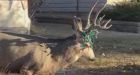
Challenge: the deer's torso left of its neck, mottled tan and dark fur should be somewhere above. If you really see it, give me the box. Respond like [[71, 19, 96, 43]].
[[0, 33, 50, 72]]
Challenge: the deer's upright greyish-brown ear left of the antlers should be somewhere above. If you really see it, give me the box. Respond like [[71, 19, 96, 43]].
[[72, 16, 83, 36]]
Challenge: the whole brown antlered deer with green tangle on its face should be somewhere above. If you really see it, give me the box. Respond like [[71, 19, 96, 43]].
[[0, 0, 112, 75]]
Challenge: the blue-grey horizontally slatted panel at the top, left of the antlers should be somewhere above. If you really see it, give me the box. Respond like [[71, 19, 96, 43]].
[[40, 0, 106, 12]]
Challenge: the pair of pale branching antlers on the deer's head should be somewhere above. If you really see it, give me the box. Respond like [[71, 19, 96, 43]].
[[85, 0, 112, 30]]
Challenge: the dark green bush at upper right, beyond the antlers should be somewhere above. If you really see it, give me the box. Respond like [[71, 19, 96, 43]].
[[103, 1, 140, 21]]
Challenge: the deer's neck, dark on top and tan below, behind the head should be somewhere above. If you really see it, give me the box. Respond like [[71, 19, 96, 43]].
[[52, 36, 80, 68]]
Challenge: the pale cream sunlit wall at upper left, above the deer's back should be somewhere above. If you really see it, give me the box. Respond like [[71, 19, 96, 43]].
[[0, 0, 30, 33]]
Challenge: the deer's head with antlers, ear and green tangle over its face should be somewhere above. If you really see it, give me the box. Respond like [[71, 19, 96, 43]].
[[73, 0, 112, 60]]
